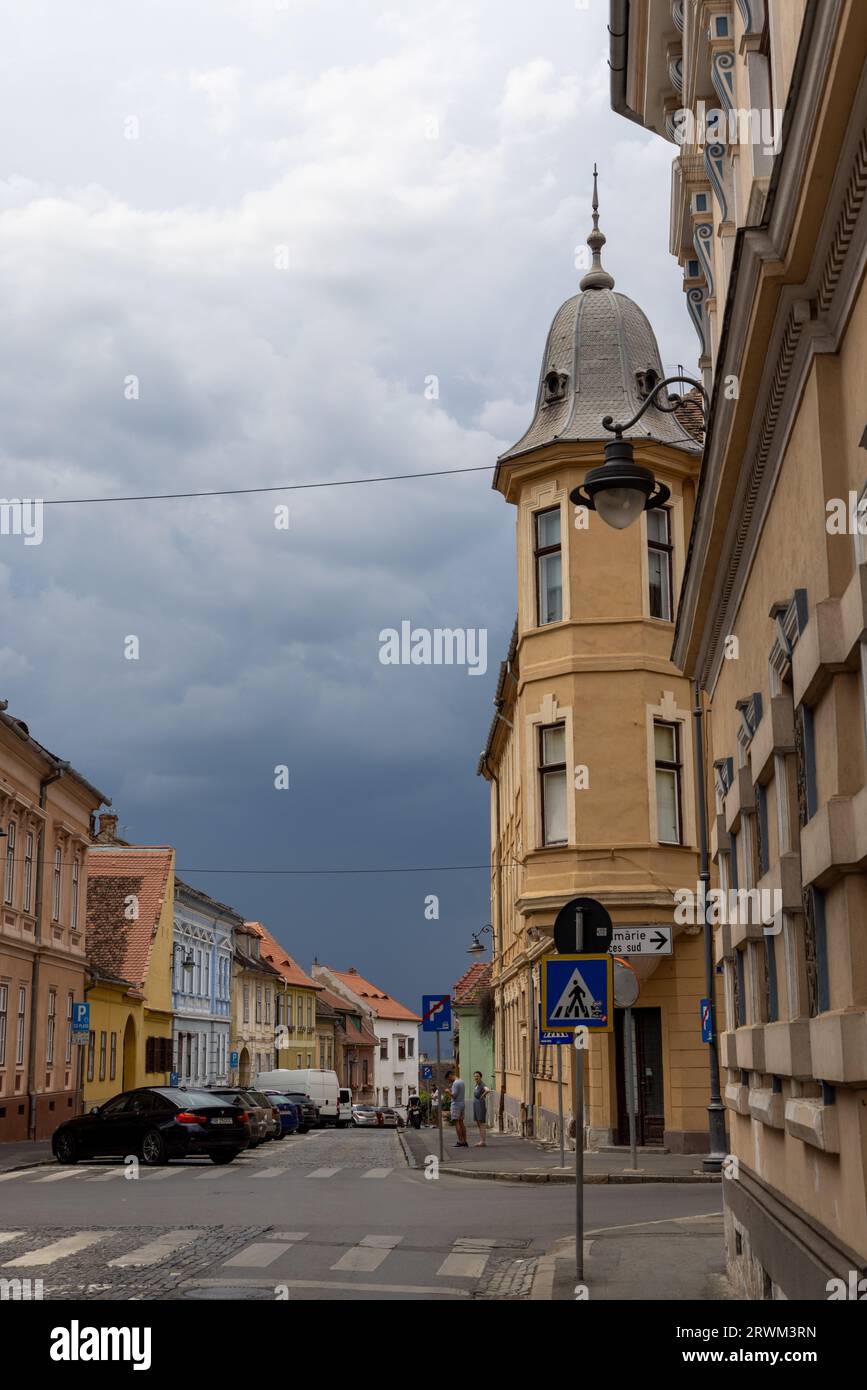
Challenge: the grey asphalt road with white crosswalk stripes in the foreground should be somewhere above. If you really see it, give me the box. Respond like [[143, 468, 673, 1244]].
[[0, 1130, 721, 1301]]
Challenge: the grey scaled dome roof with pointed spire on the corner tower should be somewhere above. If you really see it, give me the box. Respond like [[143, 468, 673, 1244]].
[[500, 167, 702, 461]]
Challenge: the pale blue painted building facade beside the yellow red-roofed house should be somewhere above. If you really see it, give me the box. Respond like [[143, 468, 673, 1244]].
[[172, 878, 243, 1086]]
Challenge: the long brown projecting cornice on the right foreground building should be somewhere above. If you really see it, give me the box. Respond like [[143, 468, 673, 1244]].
[[672, 0, 867, 688]]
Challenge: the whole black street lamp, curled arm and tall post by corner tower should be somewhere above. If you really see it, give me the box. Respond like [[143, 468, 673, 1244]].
[[570, 375, 725, 1172]]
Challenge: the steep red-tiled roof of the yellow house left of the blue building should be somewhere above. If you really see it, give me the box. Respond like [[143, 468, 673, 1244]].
[[86, 845, 175, 988]]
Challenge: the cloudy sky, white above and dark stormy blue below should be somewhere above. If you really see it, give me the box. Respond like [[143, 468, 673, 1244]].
[[0, 0, 696, 1023]]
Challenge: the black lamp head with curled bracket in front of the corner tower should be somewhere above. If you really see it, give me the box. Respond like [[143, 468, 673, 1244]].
[[570, 370, 709, 531]]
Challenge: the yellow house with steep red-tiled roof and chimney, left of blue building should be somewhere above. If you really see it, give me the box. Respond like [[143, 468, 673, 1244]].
[[85, 816, 175, 1106]]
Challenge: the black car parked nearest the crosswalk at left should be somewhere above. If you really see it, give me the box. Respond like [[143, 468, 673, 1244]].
[[51, 1086, 250, 1166]]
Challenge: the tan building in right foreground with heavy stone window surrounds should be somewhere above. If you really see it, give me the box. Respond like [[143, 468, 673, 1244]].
[[610, 0, 867, 1300]]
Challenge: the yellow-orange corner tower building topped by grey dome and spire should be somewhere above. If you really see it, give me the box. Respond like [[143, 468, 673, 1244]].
[[478, 170, 707, 1152]]
